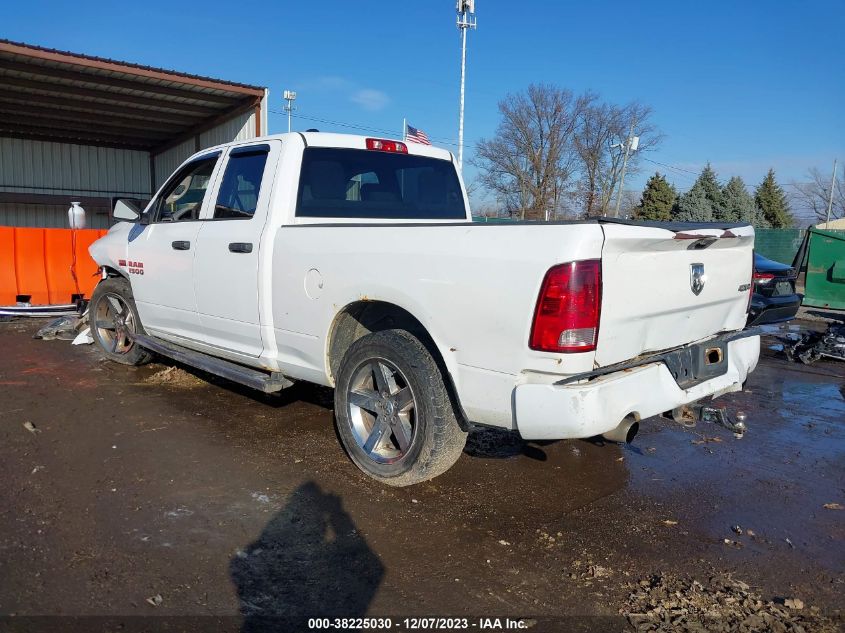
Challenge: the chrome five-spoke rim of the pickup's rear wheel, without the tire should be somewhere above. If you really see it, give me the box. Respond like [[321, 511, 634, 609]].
[[347, 358, 417, 464]]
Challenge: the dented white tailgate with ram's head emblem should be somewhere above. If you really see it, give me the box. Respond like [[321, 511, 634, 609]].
[[596, 224, 754, 366]]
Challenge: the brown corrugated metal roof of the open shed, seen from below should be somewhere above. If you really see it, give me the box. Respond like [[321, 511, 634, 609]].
[[0, 39, 265, 154]]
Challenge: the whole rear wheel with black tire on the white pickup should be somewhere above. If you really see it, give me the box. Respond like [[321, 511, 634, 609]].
[[334, 330, 467, 486]]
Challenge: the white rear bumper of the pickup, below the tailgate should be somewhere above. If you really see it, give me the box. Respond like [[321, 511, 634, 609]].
[[514, 336, 760, 440]]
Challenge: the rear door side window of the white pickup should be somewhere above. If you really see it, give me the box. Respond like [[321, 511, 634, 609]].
[[214, 145, 270, 220]]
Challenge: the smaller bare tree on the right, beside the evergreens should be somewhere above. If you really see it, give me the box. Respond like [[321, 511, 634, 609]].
[[575, 100, 663, 216]]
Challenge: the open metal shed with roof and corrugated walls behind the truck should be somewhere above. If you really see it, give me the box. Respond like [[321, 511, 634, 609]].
[[0, 40, 267, 228]]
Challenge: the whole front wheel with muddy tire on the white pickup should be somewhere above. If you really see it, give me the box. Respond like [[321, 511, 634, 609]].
[[88, 277, 153, 365]]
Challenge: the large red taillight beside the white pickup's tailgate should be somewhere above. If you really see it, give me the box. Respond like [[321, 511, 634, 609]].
[[529, 259, 601, 354]]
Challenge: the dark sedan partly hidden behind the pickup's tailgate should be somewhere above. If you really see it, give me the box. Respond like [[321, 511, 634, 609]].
[[748, 253, 801, 325]]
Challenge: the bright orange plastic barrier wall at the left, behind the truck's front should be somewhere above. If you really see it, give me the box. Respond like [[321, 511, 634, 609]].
[[0, 226, 107, 305]]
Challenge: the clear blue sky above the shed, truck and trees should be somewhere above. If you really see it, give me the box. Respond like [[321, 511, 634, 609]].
[[0, 0, 845, 212]]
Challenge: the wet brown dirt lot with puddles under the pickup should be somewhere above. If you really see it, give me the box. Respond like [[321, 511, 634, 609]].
[[0, 322, 845, 631]]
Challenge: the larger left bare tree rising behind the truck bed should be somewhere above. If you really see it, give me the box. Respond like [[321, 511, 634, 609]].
[[473, 84, 592, 220]]
